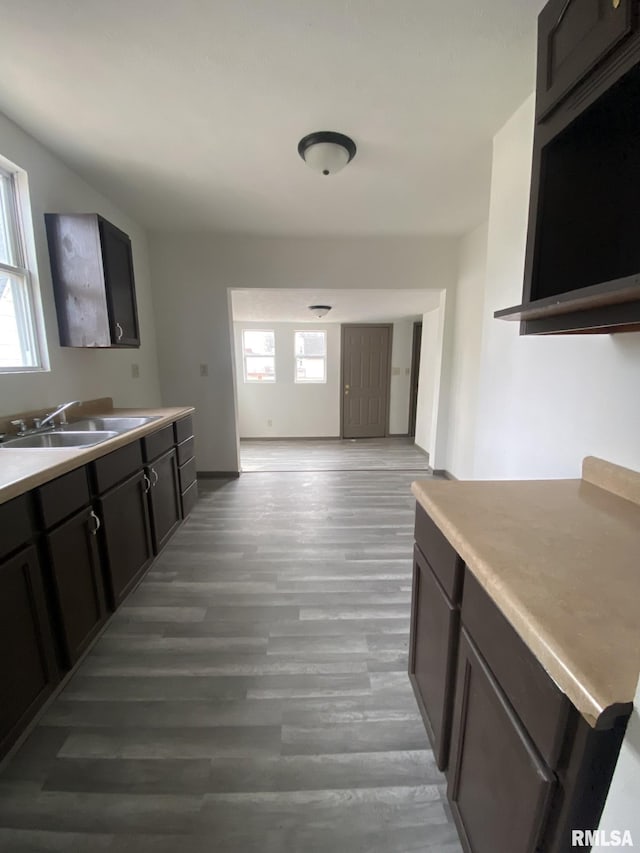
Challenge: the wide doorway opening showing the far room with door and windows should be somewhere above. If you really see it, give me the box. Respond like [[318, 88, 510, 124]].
[[229, 288, 442, 472]]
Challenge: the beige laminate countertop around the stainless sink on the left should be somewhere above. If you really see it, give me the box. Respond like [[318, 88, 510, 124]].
[[0, 406, 194, 504]]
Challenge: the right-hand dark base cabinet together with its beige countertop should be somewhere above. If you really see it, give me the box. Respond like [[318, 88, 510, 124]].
[[409, 459, 640, 853]]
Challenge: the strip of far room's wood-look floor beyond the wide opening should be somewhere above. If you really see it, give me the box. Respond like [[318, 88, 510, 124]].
[[240, 437, 429, 471]]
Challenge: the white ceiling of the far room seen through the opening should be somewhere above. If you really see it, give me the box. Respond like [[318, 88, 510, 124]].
[[231, 288, 440, 325]]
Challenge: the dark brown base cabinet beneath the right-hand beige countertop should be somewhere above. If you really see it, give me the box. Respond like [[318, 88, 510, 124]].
[[409, 500, 629, 853]]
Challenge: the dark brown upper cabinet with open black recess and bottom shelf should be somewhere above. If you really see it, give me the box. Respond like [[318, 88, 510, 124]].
[[494, 0, 640, 334]]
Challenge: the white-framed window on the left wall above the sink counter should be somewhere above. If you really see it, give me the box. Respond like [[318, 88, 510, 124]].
[[0, 168, 42, 373]]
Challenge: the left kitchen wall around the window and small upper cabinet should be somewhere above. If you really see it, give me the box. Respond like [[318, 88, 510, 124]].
[[0, 114, 160, 414]]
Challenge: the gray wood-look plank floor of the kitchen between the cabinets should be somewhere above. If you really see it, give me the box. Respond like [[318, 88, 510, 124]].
[[0, 446, 460, 853]]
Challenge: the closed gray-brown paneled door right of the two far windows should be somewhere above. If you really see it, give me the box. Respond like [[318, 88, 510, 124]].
[[342, 325, 391, 438]]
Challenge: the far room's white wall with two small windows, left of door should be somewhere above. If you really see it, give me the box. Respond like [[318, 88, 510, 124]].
[[234, 323, 340, 438]]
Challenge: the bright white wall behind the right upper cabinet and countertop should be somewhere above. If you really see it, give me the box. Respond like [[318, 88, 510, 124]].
[[472, 96, 640, 478]]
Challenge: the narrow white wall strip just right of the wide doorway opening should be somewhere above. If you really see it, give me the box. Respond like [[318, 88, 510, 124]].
[[444, 222, 488, 479]]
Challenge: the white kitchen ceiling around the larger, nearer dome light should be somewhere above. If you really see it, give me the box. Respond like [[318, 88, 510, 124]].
[[0, 0, 544, 235]]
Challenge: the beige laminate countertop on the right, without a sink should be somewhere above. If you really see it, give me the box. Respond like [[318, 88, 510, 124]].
[[412, 457, 640, 727]]
